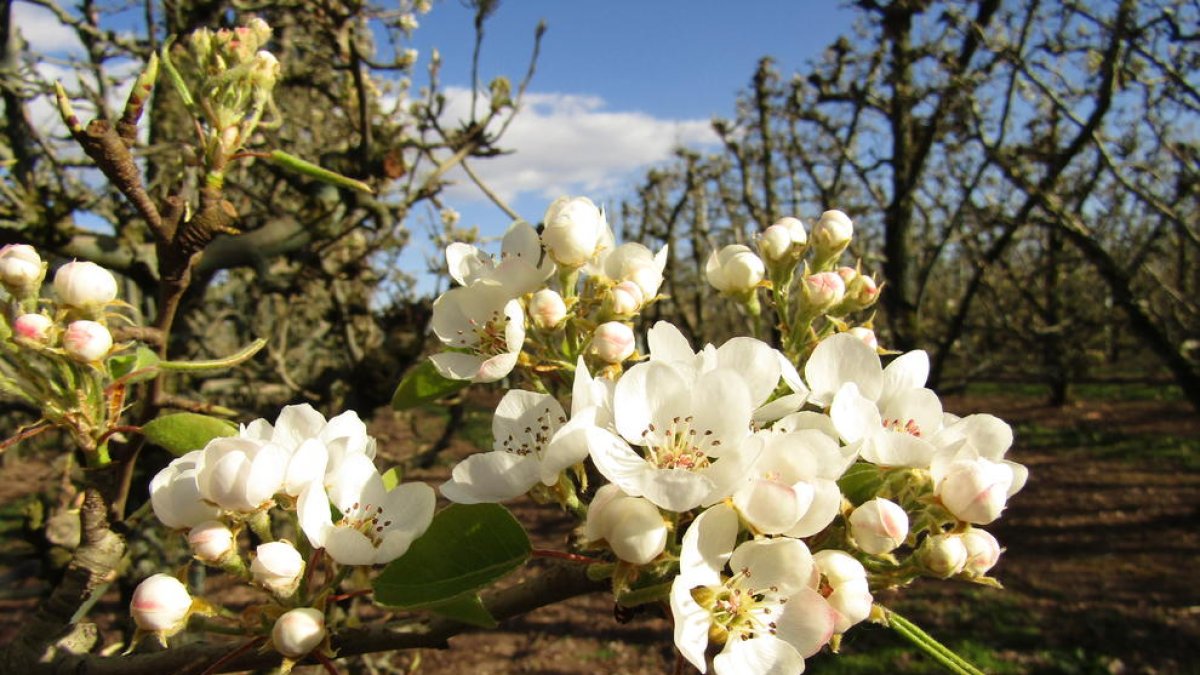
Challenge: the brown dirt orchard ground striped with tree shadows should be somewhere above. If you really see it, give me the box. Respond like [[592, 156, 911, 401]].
[[0, 396, 1200, 675]]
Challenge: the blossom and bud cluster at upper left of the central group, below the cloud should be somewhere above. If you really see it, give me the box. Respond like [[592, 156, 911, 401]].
[[432, 197, 666, 382]]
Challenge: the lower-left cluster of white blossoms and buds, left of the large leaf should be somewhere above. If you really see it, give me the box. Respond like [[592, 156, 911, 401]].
[[139, 405, 434, 670]]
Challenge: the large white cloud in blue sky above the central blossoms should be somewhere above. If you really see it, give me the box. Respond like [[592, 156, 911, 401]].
[[436, 88, 718, 202]]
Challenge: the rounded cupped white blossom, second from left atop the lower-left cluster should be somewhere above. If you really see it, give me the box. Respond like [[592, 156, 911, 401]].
[[196, 436, 290, 513]]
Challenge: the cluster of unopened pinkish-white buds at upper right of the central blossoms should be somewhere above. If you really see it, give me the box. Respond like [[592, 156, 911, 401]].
[[704, 210, 880, 358]]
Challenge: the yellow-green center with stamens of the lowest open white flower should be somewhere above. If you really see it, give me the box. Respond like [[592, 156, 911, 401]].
[[692, 568, 787, 644]]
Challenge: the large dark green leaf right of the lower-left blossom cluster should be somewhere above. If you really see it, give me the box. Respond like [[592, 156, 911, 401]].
[[374, 504, 533, 607]]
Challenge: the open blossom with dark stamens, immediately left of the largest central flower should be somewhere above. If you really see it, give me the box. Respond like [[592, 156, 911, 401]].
[[442, 386, 595, 503]]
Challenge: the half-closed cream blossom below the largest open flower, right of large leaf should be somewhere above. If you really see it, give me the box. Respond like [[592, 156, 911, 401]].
[[583, 484, 667, 565]]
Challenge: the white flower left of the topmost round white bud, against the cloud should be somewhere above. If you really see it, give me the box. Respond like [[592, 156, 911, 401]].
[[446, 220, 554, 298]]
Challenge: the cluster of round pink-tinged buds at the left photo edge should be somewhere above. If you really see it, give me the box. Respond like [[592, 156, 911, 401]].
[[0, 244, 128, 458]]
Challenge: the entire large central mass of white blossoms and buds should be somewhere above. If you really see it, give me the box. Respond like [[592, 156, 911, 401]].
[[433, 197, 1027, 674]]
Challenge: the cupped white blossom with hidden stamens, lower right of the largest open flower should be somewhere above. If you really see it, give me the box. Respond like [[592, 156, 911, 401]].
[[733, 430, 848, 537]]
